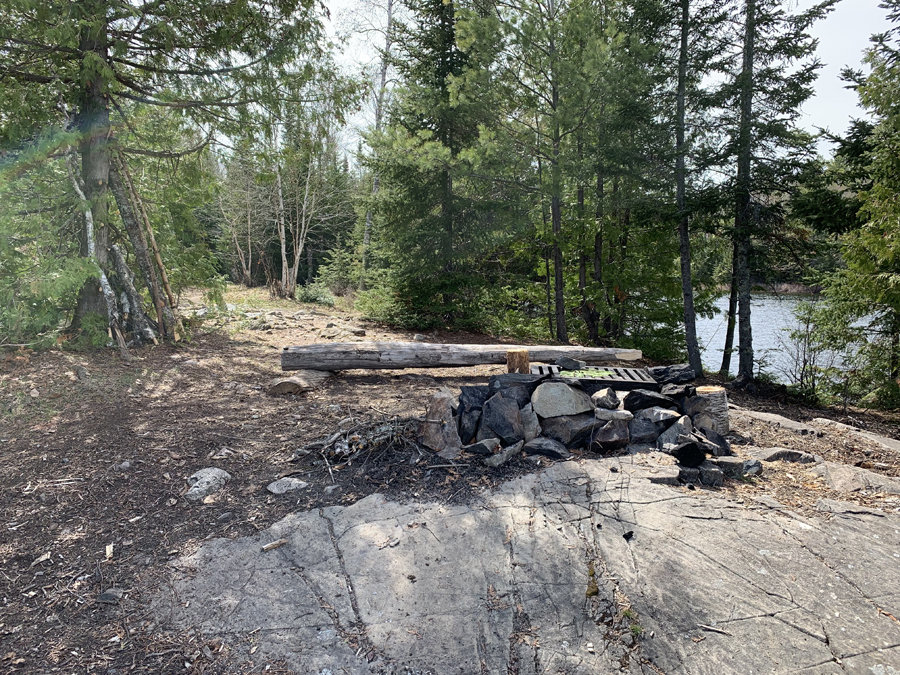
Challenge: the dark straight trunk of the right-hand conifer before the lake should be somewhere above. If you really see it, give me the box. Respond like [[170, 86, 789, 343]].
[[734, 0, 756, 383]]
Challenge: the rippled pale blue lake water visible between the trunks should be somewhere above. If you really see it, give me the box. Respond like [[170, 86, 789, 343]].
[[697, 293, 810, 383]]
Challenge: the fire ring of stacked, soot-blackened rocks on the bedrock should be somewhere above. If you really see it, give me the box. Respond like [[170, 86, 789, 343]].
[[418, 358, 762, 486]]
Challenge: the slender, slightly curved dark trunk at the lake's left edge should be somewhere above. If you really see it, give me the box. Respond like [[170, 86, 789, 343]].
[[675, 0, 703, 377]]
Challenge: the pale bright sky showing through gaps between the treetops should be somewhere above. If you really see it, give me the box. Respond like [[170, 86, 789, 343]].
[[327, 0, 889, 155]]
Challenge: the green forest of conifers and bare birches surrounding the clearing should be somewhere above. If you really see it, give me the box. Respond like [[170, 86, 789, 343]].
[[0, 0, 900, 407]]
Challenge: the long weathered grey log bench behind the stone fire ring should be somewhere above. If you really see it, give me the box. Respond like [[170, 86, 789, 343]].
[[281, 342, 642, 370]]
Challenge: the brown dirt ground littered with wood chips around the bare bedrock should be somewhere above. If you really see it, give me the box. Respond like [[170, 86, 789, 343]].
[[0, 289, 900, 673]]
